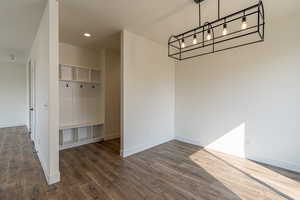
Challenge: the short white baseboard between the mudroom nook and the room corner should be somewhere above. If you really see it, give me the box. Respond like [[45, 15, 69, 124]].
[[121, 137, 174, 158]]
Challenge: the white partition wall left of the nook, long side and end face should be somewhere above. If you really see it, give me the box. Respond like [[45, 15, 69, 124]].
[[29, 0, 60, 184]]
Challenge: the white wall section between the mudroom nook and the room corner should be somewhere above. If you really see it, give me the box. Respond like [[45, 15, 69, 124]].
[[122, 31, 175, 156]]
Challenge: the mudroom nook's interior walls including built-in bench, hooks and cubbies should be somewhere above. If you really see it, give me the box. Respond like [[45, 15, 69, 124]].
[[59, 36, 121, 154]]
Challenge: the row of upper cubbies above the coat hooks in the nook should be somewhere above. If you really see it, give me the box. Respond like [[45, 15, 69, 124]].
[[59, 64, 101, 84]]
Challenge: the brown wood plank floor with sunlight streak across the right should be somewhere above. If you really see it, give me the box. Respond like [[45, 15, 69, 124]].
[[0, 127, 300, 200]]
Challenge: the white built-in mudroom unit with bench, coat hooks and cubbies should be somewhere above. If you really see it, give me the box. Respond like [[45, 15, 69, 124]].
[[59, 64, 104, 150]]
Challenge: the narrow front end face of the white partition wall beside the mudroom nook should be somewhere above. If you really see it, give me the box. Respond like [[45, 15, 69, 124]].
[[48, 0, 60, 184]]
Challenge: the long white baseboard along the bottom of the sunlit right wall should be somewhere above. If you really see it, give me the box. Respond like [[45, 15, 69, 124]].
[[175, 136, 300, 173]]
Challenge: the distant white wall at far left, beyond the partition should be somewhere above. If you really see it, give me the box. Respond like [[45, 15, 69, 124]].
[[0, 62, 28, 128]]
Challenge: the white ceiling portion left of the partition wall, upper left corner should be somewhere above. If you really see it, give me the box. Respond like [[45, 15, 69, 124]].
[[0, 0, 45, 63]]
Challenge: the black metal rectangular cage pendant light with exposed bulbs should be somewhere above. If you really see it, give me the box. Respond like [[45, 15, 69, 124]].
[[168, 0, 265, 60]]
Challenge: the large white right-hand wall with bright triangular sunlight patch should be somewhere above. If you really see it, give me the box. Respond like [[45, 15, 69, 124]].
[[176, 16, 300, 171]]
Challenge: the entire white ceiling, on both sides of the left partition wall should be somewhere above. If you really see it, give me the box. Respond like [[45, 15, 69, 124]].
[[0, 0, 300, 62]]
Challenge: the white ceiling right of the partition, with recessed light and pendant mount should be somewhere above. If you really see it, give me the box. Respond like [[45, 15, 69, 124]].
[[60, 0, 299, 48]]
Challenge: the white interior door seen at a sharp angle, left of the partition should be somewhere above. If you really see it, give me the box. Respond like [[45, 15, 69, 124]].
[[28, 61, 38, 151]]
